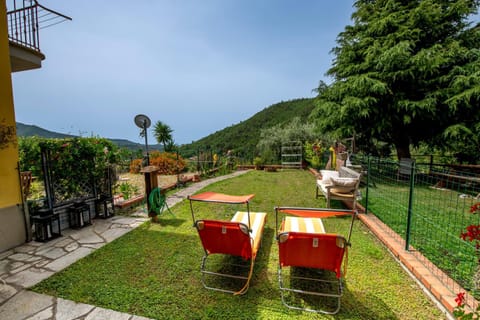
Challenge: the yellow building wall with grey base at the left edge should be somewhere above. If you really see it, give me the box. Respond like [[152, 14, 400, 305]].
[[0, 0, 26, 252]]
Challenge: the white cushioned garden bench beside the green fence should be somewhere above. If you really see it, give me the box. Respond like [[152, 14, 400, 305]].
[[316, 167, 361, 208]]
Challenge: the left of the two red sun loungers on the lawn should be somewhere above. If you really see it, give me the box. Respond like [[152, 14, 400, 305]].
[[188, 192, 267, 295]]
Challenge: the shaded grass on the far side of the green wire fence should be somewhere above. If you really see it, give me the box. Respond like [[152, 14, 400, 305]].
[[363, 179, 480, 297]]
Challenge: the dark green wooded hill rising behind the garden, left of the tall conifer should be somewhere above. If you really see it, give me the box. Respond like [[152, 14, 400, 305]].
[[176, 98, 314, 160]]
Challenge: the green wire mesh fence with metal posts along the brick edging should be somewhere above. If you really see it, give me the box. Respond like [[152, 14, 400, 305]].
[[351, 156, 480, 298]]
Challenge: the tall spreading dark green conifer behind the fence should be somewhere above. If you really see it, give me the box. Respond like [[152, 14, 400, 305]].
[[312, 0, 480, 158]]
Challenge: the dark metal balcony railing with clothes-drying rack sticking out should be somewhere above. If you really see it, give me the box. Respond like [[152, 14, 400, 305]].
[[7, 0, 72, 52]]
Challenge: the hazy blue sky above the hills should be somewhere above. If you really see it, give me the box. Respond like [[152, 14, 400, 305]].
[[12, 0, 354, 144]]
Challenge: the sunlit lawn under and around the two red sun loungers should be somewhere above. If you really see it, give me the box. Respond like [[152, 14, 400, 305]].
[[32, 170, 443, 319]]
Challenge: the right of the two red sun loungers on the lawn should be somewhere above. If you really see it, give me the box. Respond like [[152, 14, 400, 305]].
[[275, 207, 356, 314]]
